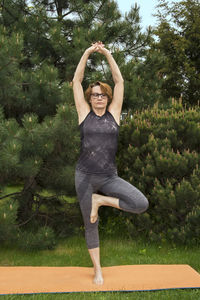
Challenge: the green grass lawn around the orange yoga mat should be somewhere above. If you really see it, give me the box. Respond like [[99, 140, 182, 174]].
[[0, 236, 200, 300]]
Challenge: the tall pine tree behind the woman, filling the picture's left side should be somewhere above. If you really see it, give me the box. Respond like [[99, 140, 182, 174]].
[[0, 0, 150, 232]]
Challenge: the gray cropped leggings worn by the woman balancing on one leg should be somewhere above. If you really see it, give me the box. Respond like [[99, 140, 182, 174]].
[[75, 170, 149, 249]]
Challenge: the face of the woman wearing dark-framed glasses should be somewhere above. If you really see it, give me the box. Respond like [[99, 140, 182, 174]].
[[90, 85, 108, 109]]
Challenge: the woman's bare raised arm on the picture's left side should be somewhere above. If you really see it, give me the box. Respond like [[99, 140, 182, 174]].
[[72, 45, 97, 124]]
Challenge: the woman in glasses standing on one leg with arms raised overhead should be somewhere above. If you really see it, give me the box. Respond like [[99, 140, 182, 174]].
[[73, 42, 148, 284]]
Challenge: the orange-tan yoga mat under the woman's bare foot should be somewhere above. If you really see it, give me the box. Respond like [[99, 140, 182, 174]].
[[0, 265, 200, 295]]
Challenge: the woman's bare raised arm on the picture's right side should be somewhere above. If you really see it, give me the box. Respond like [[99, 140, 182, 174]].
[[97, 44, 124, 124]]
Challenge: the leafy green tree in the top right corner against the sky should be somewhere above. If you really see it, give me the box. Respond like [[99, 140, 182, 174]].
[[155, 0, 200, 105]]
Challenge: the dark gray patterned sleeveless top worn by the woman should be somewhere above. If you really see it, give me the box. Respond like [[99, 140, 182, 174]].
[[76, 110, 119, 174]]
